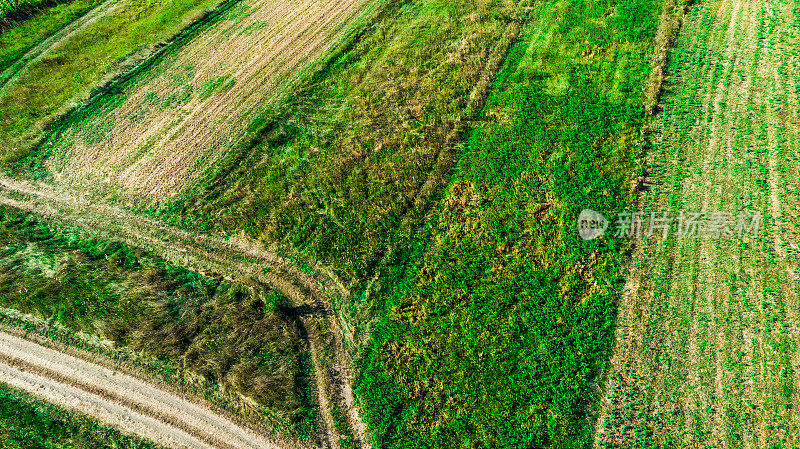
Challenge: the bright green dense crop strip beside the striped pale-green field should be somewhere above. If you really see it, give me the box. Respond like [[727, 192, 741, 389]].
[[359, 0, 660, 448]]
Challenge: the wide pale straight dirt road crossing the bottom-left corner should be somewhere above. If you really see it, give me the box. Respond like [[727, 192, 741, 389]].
[[0, 333, 278, 449]]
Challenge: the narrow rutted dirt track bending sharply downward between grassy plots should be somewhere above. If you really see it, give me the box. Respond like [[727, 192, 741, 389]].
[[0, 178, 370, 449]]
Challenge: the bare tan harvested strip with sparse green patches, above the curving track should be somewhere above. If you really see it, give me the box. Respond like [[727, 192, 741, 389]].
[[47, 0, 376, 200]]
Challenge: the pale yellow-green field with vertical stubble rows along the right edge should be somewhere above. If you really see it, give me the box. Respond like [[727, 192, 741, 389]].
[[596, 0, 800, 448]]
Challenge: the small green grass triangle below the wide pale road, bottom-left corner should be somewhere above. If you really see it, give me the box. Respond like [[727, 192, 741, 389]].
[[0, 384, 157, 449]]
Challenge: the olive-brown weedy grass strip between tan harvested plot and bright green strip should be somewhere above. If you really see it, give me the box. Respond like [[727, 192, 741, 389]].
[[162, 0, 519, 280]]
